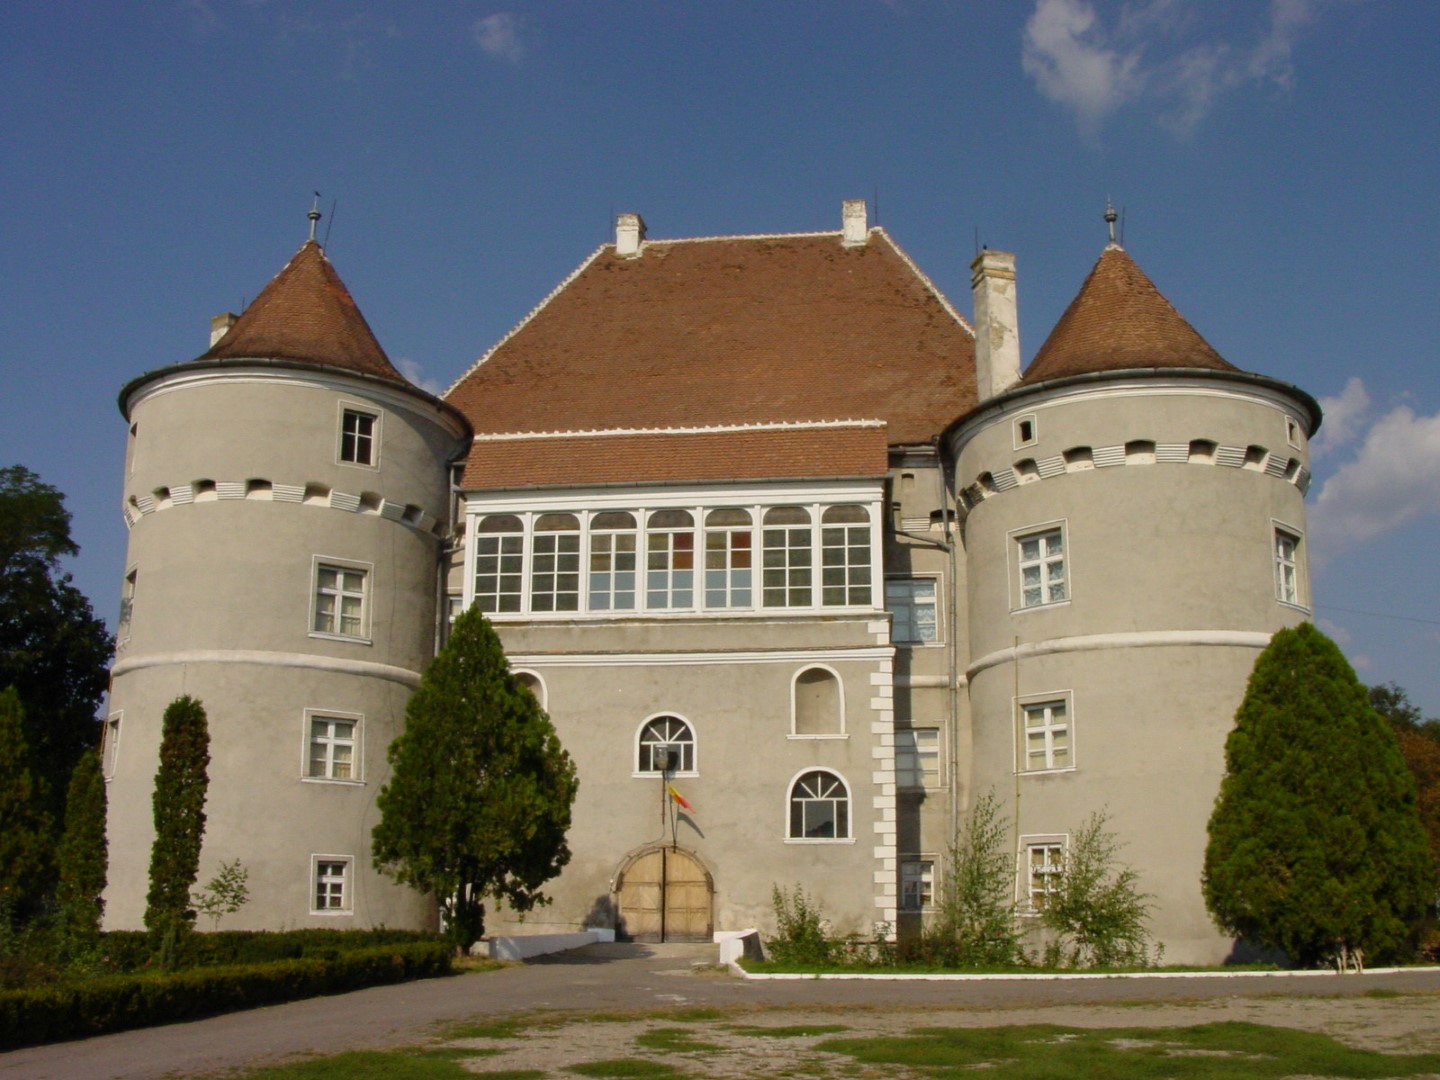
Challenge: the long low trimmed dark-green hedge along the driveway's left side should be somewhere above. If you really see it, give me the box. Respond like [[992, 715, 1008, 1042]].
[[0, 940, 452, 1050]]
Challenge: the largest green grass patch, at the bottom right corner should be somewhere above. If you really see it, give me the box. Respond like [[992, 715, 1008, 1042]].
[[816, 1022, 1440, 1080]]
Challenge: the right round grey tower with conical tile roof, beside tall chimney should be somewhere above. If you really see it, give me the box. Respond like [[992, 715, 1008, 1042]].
[[948, 243, 1320, 962]]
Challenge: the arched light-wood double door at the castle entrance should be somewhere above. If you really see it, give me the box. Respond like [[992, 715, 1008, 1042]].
[[615, 847, 714, 942]]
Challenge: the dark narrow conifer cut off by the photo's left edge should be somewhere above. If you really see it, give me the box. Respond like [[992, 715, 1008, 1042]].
[[0, 687, 53, 917]]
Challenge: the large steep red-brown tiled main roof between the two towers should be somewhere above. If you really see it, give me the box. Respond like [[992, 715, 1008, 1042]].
[[445, 229, 976, 487]]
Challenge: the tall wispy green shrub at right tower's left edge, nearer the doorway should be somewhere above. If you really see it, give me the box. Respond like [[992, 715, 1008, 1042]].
[[924, 792, 1021, 968]]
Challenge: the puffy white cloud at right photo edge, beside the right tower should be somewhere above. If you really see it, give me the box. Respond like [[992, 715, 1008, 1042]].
[[1310, 406, 1440, 554]]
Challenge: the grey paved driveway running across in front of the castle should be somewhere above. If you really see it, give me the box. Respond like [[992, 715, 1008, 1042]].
[[8, 945, 1440, 1080]]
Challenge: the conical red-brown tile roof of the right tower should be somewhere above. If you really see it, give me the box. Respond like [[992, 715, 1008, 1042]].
[[1024, 243, 1240, 383]]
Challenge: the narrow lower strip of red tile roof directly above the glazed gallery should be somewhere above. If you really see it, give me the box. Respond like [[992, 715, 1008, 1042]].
[[461, 423, 887, 490]]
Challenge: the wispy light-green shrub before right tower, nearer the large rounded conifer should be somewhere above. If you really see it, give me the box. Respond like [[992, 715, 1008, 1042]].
[[1040, 812, 1151, 968]]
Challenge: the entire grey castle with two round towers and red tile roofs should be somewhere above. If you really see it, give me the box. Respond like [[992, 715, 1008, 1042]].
[[104, 202, 1320, 962]]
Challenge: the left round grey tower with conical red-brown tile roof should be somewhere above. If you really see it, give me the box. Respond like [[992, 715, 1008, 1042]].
[[105, 240, 469, 929]]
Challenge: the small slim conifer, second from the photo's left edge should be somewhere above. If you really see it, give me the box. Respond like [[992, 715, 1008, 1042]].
[[55, 750, 108, 955]]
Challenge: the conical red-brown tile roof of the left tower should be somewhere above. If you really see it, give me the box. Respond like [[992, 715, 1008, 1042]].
[[197, 240, 409, 384]]
